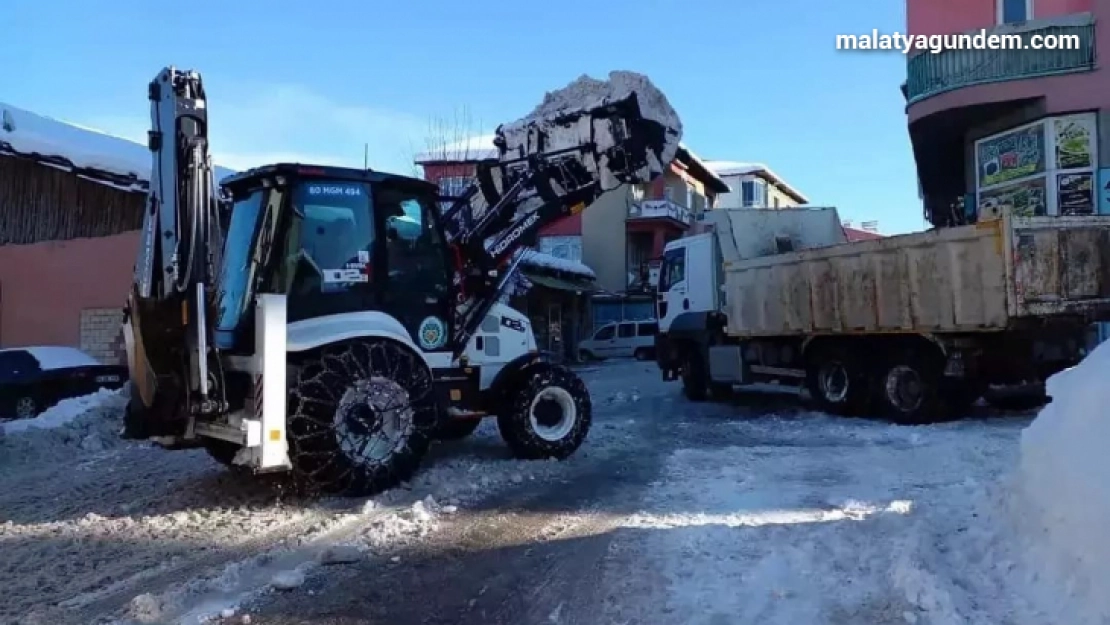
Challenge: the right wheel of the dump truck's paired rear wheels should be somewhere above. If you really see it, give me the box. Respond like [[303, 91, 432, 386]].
[[875, 352, 948, 425]]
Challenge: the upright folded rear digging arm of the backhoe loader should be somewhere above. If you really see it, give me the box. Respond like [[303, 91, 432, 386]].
[[124, 68, 226, 432]]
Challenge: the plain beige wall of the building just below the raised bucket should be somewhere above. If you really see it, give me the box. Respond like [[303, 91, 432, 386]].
[[581, 185, 632, 292]]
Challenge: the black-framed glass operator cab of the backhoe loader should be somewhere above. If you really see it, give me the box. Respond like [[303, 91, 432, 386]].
[[216, 164, 454, 352]]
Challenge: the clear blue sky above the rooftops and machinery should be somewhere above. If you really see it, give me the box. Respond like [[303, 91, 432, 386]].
[[0, 0, 924, 233]]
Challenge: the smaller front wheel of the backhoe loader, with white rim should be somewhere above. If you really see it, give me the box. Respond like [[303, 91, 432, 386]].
[[497, 365, 593, 460]]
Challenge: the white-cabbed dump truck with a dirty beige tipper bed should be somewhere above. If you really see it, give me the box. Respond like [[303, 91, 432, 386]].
[[656, 208, 1110, 424]]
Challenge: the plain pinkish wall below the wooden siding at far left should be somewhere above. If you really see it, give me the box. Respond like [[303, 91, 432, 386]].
[[0, 232, 139, 357]]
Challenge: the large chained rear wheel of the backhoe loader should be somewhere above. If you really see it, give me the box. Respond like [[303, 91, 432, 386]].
[[287, 339, 435, 496]]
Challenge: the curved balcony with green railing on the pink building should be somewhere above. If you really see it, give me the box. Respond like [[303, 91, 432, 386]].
[[904, 13, 1094, 105]]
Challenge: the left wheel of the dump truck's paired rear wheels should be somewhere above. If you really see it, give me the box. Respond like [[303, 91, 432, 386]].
[[806, 346, 870, 416]]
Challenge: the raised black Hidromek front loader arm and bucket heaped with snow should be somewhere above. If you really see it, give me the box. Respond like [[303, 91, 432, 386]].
[[444, 72, 682, 356]]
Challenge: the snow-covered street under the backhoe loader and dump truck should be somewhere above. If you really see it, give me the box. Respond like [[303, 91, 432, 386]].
[[0, 357, 1110, 625]]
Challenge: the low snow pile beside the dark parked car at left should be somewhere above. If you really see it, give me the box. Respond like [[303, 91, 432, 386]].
[[0, 389, 127, 463]]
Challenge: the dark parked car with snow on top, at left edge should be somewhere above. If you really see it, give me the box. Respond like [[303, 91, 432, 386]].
[[0, 345, 128, 421]]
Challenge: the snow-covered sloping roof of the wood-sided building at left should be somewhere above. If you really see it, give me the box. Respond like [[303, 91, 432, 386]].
[[0, 102, 235, 191]]
